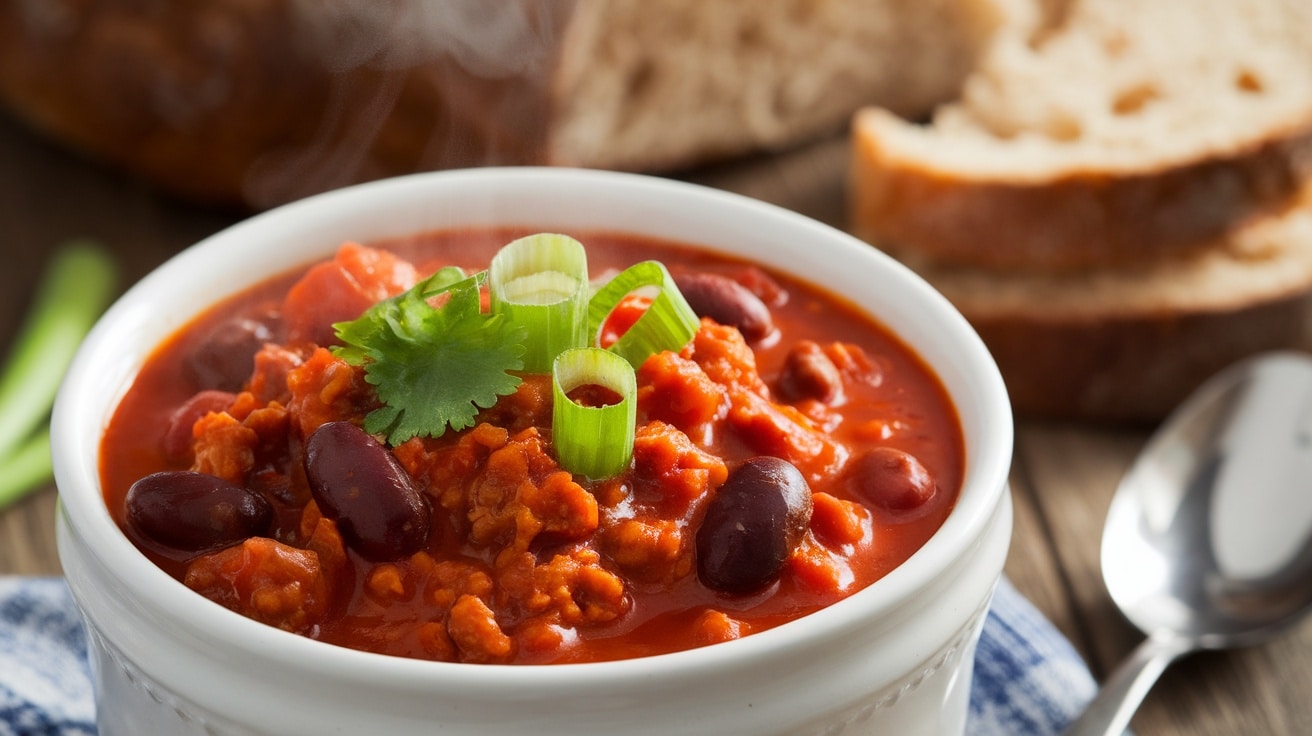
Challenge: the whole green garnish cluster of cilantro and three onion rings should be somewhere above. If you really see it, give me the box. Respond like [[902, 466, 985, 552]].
[[333, 234, 698, 456]]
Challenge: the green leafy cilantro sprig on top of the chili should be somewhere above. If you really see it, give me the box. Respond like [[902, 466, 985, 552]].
[[333, 268, 526, 446]]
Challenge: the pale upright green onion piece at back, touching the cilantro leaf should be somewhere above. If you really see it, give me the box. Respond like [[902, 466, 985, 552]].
[[488, 234, 588, 373]]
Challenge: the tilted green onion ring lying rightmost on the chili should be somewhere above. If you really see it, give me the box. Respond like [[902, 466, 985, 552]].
[[588, 261, 699, 367]]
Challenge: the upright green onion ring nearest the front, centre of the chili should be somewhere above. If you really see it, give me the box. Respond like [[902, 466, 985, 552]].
[[551, 348, 638, 480]]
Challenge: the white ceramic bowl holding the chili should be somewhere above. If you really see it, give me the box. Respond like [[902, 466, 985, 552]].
[[52, 169, 1013, 736]]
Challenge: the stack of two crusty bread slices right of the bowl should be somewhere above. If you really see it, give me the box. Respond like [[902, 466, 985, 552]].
[[849, 0, 1312, 421]]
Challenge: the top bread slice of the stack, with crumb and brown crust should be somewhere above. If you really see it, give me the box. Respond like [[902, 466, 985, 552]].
[[850, 0, 1312, 270]]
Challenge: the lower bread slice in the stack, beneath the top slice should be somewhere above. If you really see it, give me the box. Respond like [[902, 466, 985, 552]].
[[905, 181, 1312, 422]]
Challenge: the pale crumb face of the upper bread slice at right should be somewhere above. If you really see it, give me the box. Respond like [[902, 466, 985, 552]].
[[866, 0, 1312, 171]]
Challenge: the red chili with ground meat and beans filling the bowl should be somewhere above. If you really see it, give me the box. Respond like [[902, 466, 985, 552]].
[[101, 230, 964, 664]]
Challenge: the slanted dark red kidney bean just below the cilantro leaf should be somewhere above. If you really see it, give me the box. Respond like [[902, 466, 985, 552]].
[[306, 421, 429, 560]]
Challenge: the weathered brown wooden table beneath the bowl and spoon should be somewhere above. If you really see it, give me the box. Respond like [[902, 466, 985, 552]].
[[0, 110, 1312, 736]]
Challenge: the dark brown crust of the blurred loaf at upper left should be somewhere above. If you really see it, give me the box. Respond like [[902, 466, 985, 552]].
[[0, 0, 572, 209]]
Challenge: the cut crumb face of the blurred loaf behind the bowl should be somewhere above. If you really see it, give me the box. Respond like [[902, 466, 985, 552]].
[[552, 0, 1019, 168]]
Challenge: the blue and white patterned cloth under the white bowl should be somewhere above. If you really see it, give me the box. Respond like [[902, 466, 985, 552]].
[[0, 577, 1094, 736]]
